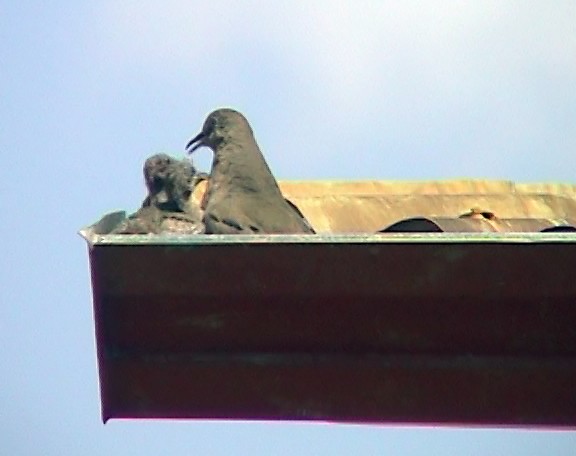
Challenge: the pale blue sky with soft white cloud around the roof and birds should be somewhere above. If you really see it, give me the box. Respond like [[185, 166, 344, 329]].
[[0, 0, 576, 456]]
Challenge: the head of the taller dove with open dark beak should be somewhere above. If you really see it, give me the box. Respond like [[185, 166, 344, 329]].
[[186, 108, 252, 154]]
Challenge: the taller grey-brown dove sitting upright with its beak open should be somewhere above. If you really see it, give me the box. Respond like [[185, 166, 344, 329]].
[[186, 109, 314, 234]]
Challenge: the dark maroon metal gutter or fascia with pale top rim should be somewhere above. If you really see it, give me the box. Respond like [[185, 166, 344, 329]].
[[84, 233, 576, 427]]
